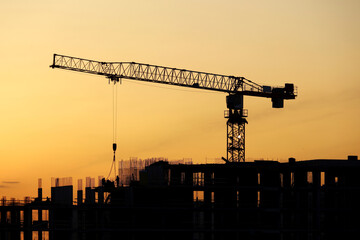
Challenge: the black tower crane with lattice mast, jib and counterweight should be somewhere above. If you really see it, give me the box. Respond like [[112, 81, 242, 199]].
[[50, 54, 297, 162]]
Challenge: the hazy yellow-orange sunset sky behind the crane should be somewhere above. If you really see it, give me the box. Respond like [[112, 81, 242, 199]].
[[0, 0, 360, 198]]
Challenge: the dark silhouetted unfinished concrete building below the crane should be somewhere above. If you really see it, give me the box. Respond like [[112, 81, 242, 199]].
[[0, 156, 360, 240]]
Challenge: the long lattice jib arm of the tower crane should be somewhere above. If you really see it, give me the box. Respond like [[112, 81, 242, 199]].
[[51, 54, 287, 96]]
